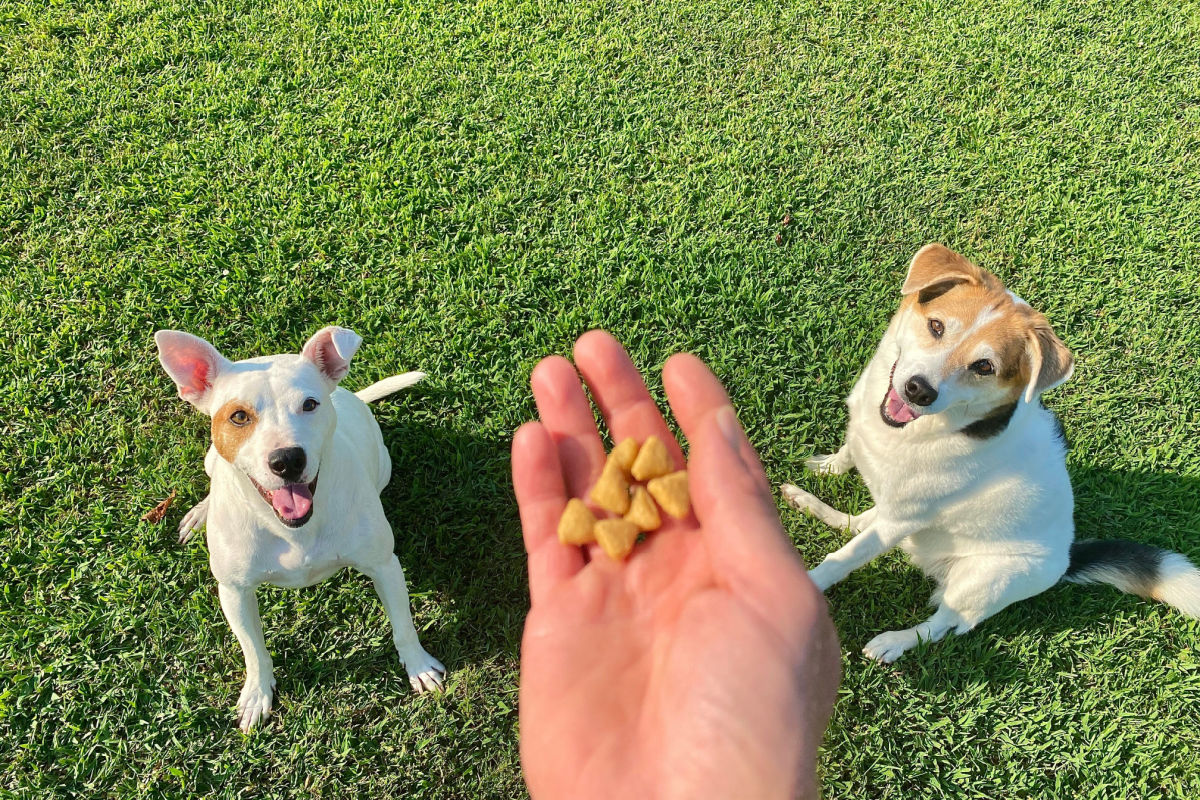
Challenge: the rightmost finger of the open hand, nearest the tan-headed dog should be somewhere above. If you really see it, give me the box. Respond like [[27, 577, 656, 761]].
[[662, 355, 803, 587]]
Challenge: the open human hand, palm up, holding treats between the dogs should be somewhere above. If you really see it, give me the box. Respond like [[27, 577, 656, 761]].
[[512, 331, 839, 800]]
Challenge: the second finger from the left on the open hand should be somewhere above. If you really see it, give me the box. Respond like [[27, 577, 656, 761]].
[[529, 356, 604, 498]]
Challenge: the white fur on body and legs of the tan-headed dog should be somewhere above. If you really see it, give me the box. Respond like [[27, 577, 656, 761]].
[[782, 312, 1074, 662]]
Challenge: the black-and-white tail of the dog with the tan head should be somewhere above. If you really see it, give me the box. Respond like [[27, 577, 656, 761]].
[[1062, 539, 1200, 618]]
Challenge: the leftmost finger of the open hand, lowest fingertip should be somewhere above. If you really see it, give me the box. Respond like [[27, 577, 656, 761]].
[[512, 422, 583, 603]]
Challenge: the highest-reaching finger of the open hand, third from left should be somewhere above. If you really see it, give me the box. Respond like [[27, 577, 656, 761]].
[[575, 331, 684, 469]]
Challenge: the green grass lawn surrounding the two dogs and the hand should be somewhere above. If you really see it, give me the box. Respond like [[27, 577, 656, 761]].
[[0, 0, 1200, 799]]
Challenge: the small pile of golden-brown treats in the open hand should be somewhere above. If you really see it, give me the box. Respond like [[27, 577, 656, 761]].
[[558, 437, 691, 561]]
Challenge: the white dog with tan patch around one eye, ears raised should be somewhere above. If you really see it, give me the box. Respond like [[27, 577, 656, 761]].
[[155, 327, 445, 730]]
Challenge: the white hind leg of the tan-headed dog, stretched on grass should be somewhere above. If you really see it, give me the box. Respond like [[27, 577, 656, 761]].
[[863, 555, 1061, 663]]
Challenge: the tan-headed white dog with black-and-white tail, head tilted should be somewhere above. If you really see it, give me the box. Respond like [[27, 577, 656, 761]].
[[781, 245, 1200, 662]]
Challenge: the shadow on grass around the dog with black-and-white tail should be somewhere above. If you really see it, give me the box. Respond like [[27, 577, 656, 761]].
[[829, 468, 1200, 685]]
